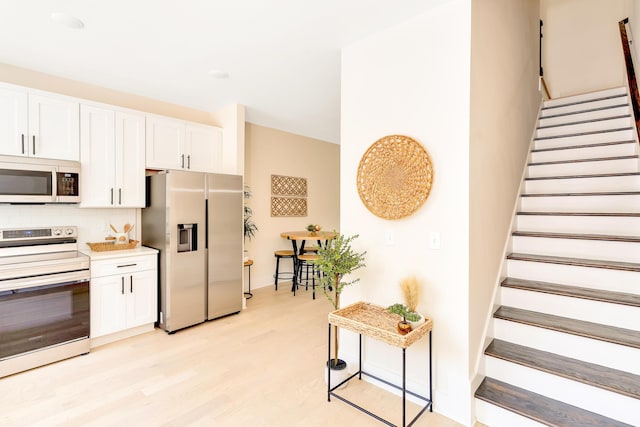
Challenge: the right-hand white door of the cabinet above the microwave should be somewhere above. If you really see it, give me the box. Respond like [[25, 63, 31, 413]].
[[29, 94, 80, 161]]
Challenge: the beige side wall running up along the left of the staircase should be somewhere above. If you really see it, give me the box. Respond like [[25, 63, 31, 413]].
[[469, 0, 540, 392]]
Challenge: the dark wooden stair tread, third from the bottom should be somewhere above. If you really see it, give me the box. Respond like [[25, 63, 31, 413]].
[[493, 306, 640, 349]]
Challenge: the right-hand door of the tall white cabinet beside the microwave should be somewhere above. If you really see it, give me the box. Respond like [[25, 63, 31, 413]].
[[115, 111, 145, 208]]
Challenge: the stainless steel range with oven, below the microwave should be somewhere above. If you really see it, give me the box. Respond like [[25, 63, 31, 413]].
[[0, 227, 90, 377]]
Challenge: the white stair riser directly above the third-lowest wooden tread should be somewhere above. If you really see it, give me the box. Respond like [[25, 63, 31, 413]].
[[501, 286, 640, 332]]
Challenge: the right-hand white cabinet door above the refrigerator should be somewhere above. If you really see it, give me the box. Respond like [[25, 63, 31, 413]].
[[184, 123, 222, 172]]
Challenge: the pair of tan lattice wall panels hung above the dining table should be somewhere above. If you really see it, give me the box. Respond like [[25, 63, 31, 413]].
[[271, 175, 307, 217]]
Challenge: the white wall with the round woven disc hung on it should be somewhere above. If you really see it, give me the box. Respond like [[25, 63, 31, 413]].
[[340, 0, 472, 424]]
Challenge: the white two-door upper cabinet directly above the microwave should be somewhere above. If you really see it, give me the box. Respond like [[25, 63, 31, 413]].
[[0, 86, 80, 161]]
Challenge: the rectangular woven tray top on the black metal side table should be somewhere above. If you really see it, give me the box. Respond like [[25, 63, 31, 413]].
[[329, 302, 433, 348]]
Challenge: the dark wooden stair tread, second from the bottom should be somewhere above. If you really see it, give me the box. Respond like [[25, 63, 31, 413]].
[[484, 339, 640, 403]]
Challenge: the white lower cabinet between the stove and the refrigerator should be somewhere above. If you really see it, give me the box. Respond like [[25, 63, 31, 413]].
[[90, 251, 158, 339]]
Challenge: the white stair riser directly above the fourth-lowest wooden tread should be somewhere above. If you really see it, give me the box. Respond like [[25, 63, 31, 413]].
[[507, 259, 640, 294]]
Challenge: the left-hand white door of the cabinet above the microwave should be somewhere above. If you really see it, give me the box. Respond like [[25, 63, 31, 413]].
[[0, 88, 29, 156]]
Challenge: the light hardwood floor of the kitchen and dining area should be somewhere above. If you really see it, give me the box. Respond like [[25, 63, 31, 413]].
[[0, 284, 459, 427]]
